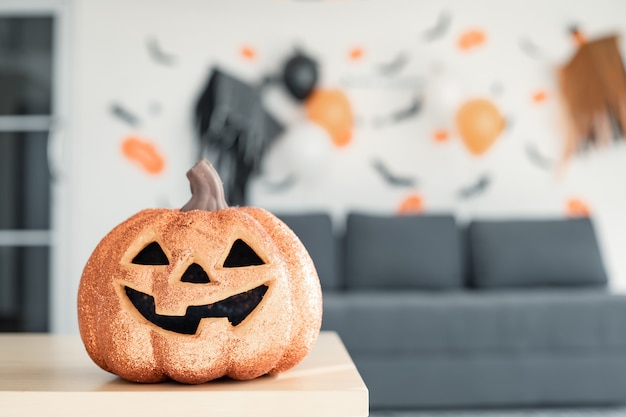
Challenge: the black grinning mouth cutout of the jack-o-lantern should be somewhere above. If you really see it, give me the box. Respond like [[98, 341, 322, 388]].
[[124, 285, 268, 335]]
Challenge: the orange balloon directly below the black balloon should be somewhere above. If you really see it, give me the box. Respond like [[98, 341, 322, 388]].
[[305, 89, 353, 147]]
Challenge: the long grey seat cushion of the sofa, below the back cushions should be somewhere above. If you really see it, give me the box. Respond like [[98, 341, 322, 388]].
[[322, 287, 626, 356]]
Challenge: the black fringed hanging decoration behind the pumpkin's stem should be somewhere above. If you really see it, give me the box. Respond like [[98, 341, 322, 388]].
[[195, 68, 283, 205]]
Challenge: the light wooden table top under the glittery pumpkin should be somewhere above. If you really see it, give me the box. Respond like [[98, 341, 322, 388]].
[[0, 332, 369, 417]]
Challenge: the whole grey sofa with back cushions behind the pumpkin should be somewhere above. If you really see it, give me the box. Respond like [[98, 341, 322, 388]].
[[279, 213, 626, 409]]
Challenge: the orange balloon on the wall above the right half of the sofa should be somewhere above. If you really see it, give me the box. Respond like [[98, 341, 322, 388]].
[[456, 99, 505, 155]]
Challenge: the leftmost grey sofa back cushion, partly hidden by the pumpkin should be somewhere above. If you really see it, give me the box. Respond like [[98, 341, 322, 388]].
[[277, 213, 342, 290]]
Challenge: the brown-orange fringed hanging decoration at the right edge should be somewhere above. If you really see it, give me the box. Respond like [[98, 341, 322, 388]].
[[559, 36, 626, 159]]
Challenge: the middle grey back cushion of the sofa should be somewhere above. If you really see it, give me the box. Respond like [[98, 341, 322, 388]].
[[345, 213, 463, 289]]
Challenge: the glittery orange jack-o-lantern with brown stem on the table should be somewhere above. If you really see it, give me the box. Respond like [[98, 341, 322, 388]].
[[78, 161, 322, 383]]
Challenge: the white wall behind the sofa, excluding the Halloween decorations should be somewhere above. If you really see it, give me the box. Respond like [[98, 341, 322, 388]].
[[53, 0, 626, 331]]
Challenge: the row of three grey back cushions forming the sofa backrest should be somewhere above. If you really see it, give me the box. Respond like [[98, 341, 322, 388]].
[[278, 213, 607, 291]]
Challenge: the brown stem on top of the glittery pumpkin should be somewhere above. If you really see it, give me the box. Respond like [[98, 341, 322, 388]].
[[180, 159, 228, 211]]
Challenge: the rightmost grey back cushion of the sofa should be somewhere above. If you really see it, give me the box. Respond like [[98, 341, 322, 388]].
[[468, 218, 607, 288]]
